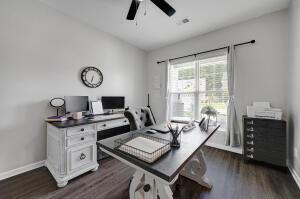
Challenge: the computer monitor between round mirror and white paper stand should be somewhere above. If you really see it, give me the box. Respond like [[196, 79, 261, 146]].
[[65, 96, 89, 114]]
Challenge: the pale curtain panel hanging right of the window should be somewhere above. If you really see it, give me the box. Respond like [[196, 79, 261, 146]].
[[225, 45, 241, 147]]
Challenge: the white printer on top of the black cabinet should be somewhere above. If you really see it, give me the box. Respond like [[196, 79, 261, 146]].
[[247, 102, 282, 120]]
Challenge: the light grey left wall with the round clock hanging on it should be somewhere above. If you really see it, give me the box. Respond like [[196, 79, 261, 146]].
[[0, 0, 147, 173]]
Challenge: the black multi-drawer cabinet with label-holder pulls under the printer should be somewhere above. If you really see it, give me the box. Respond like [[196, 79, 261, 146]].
[[243, 116, 287, 167]]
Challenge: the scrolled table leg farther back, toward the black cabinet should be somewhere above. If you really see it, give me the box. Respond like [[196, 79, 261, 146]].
[[180, 150, 212, 189]]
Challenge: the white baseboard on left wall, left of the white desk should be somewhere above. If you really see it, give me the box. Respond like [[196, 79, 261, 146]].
[[0, 160, 45, 180]]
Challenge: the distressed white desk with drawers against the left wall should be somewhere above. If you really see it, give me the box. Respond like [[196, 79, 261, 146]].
[[46, 114, 129, 187]]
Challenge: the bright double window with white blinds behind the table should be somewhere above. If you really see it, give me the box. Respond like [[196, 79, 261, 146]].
[[169, 53, 229, 130]]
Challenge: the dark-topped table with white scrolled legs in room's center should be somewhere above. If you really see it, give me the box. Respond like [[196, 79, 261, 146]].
[[98, 123, 217, 199]]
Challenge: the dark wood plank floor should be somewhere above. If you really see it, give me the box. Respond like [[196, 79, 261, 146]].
[[0, 147, 300, 199]]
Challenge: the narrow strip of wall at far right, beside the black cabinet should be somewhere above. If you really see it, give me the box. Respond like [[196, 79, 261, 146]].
[[288, 0, 300, 179]]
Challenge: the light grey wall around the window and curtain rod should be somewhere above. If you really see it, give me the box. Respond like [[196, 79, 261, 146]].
[[148, 10, 288, 146]]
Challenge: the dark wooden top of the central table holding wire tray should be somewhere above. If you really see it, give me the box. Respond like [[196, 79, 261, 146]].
[[97, 126, 216, 182]]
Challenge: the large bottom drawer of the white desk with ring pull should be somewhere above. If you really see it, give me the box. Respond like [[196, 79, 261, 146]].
[[67, 143, 96, 173]]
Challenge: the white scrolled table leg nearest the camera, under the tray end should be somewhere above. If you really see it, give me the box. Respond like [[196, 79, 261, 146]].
[[129, 170, 177, 199]]
